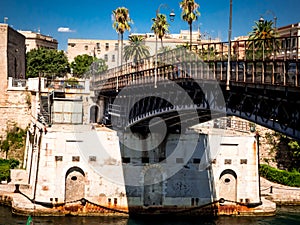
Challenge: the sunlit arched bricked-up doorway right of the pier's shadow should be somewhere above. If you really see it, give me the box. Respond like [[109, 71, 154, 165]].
[[219, 169, 237, 201]]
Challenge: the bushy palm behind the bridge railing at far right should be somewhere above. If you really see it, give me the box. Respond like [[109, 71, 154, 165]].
[[247, 20, 279, 59]]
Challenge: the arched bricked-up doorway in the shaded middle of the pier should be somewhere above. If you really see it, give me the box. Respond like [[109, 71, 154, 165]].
[[144, 167, 163, 206]]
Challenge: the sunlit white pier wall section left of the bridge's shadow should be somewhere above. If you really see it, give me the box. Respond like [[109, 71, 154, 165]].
[[22, 125, 127, 209]]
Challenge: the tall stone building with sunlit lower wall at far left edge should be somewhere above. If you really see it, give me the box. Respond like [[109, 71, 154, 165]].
[[0, 24, 30, 137]]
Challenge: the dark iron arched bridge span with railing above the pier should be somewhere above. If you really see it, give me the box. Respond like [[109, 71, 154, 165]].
[[92, 45, 300, 140]]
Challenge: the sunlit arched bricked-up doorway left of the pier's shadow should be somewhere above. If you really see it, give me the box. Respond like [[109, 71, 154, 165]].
[[65, 166, 85, 202]]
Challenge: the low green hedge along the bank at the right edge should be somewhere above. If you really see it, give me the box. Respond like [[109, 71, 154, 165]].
[[259, 164, 300, 187]]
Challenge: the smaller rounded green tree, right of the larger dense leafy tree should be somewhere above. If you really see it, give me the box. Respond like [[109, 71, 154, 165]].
[[71, 54, 95, 78]]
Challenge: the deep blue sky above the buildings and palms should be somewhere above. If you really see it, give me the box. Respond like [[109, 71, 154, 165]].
[[0, 0, 300, 50]]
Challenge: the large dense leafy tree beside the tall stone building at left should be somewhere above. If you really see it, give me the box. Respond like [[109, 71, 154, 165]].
[[26, 48, 69, 78]]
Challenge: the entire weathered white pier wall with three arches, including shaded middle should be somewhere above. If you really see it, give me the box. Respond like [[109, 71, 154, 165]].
[[16, 124, 260, 215]]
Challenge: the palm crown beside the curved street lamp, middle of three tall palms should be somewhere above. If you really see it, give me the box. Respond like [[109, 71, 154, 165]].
[[151, 14, 170, 48]]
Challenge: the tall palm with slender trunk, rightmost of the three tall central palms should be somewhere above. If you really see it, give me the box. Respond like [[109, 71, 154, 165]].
[[179, 0, 200, 50]]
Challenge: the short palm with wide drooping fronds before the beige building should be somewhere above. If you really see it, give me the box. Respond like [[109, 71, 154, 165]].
[[124, 35, 150, 63]]
